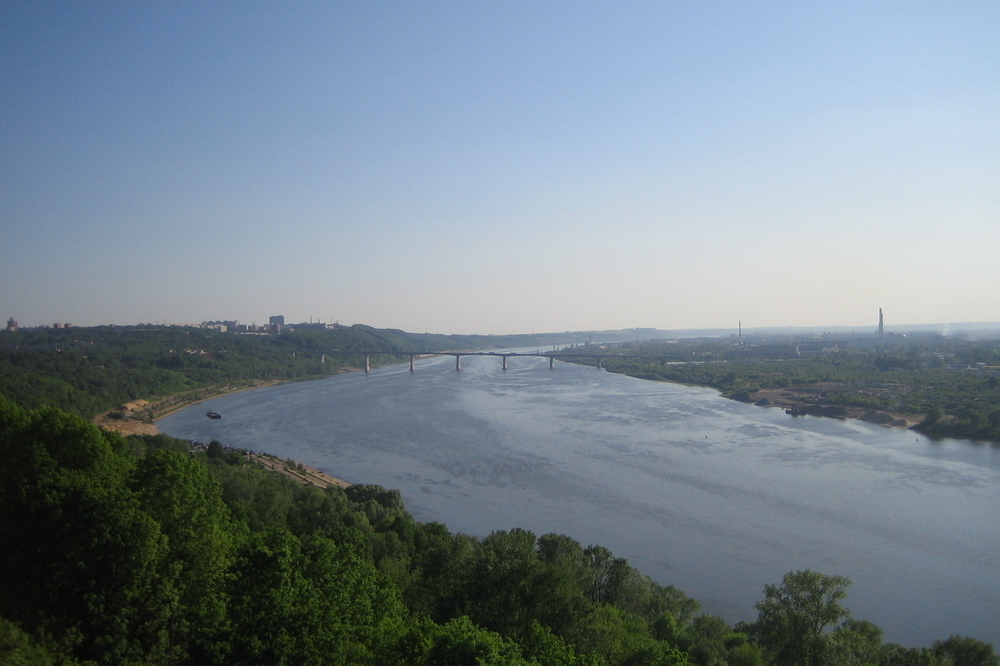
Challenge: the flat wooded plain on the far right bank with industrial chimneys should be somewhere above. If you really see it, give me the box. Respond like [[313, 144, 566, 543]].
[[552, 334, 1000, 441]]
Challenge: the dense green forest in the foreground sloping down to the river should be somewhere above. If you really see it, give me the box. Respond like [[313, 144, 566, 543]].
[[0, 401, 998, 666]]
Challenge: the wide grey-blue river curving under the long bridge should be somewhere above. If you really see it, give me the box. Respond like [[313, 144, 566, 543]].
[[158, 357, 1000, 647]]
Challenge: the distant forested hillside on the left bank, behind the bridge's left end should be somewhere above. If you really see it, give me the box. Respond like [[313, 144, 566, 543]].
[[0, 325, 582, 418]]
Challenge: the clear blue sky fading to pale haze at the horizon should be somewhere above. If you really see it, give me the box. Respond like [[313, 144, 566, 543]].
[[0, 0, 1000, 333]]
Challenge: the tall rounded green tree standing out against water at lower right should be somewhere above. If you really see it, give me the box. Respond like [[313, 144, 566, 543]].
[[754, 569, 851, 666]]
